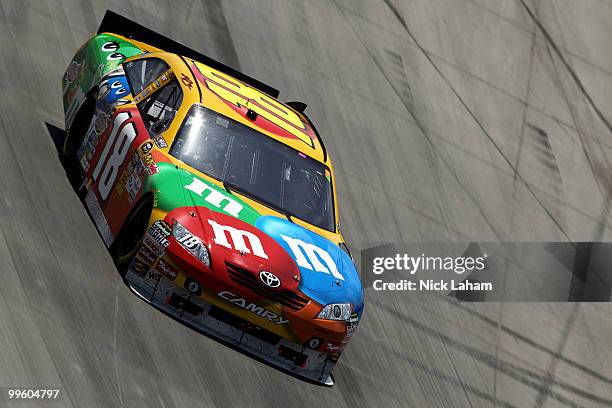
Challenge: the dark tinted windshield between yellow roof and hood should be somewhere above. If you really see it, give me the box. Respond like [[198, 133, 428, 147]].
[[170, 105, 335, 231]]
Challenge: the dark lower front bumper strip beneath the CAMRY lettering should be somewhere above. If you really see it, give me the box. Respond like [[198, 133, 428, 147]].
[[125, 263, 336, 386]]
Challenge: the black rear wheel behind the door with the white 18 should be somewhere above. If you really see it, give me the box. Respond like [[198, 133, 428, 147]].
[[60, 95, 96, 193]]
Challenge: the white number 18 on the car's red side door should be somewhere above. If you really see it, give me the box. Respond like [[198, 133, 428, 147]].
[[92, 112, 137, 201]]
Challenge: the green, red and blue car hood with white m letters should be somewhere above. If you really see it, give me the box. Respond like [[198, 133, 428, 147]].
[[148, 163, 363, 312]]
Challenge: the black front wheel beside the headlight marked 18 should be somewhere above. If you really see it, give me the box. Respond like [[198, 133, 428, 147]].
[[110, 195, 153, 276]]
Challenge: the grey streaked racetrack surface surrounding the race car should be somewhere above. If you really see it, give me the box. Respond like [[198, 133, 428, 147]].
[[0, 0, 612, 407]]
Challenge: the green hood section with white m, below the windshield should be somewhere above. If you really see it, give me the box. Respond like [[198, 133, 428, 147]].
[[143, 163, 260, 225]]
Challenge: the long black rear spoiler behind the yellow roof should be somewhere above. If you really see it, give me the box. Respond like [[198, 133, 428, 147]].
[[98, 10, 280, 98]]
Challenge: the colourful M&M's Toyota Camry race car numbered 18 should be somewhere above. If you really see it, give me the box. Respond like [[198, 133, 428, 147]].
[[60, 11, 364, 385]]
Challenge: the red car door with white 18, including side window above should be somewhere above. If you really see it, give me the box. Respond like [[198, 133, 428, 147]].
[[85, 58, 182, 246]]
